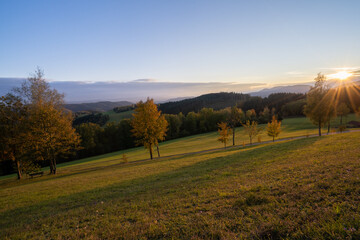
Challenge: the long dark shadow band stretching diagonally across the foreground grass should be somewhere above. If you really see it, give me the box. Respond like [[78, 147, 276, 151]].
[[0, 138, 318, 233]]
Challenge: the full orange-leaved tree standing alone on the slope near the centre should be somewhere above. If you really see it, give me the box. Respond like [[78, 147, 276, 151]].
[[131, 98, 168, 159]]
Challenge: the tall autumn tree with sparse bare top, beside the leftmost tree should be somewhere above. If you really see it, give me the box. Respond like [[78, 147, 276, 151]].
[[15, 68, 80, 174]]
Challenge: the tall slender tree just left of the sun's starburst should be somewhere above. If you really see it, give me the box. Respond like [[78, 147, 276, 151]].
[[304, 73, 334, 136]]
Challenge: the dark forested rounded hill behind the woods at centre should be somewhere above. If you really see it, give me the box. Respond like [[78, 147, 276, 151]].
[[159, 92, 250, 114]]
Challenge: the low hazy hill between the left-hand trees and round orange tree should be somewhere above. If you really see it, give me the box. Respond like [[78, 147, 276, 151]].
[[65, 101, 133, 112]]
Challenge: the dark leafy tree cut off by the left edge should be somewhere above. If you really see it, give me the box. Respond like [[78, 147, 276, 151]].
[[0, 94, 30, 179]]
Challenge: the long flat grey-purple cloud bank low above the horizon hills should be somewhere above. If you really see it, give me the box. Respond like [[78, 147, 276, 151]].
[[0, 78, 266, 102]]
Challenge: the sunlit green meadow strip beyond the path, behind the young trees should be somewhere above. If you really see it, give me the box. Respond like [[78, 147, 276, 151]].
[[0, 114, 360, 180]]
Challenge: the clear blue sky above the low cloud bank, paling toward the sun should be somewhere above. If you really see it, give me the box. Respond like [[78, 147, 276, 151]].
[[0, 0, 360, 84]]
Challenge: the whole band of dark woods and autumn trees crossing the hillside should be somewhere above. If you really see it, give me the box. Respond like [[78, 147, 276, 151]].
[[0, 69, 360, 179]]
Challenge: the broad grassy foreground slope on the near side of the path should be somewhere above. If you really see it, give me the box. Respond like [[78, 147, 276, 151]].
[[0, 133, 360, 239]]
